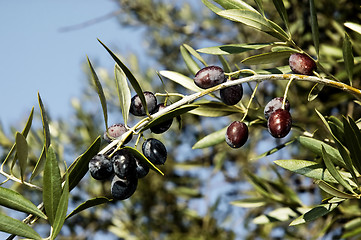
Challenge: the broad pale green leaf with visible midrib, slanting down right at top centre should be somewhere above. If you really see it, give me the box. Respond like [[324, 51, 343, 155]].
[[217, 9, 288, 41]]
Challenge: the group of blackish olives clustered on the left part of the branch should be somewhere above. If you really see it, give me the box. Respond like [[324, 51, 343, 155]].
[[89, 92, 173, 200]]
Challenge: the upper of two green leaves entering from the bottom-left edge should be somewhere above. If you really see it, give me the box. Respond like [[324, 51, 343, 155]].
[[0, 187, 46, 219]]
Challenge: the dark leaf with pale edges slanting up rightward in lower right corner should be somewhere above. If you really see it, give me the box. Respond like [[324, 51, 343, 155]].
[[290, 203, 339, 226]]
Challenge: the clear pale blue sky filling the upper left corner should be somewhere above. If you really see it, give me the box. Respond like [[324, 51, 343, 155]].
[[0, 0, 140, 130]]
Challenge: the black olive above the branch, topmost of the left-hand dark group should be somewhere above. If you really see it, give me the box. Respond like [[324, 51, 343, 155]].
[[129, 91, 157, 116]]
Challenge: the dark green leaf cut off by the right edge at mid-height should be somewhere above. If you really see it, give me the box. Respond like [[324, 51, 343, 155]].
[[343, 117, 361, 174]]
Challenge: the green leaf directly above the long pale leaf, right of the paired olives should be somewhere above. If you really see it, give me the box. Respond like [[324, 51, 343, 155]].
[[298, 136, 347, 168]]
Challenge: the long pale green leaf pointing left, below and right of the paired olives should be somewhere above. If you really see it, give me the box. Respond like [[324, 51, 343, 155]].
[[274, 159, 355, 185]]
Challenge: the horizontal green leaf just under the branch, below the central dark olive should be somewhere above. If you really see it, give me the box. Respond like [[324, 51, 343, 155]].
[[189, 101, 244, 117]]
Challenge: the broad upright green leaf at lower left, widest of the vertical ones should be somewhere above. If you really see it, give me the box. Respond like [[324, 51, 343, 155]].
[[43, 146, 62, 226]]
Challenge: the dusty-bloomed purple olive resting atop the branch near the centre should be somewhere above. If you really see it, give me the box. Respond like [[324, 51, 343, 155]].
[[194, 66, 226, 89]]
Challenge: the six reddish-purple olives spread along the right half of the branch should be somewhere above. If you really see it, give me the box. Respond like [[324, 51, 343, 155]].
[[194, 53, 316, 148]]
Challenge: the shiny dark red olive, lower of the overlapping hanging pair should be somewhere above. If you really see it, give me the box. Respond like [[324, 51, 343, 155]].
[[267, 108, 292, 138]]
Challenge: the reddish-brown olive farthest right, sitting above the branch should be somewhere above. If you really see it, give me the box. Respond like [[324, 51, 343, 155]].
[[289, 53, 316, 75]]
